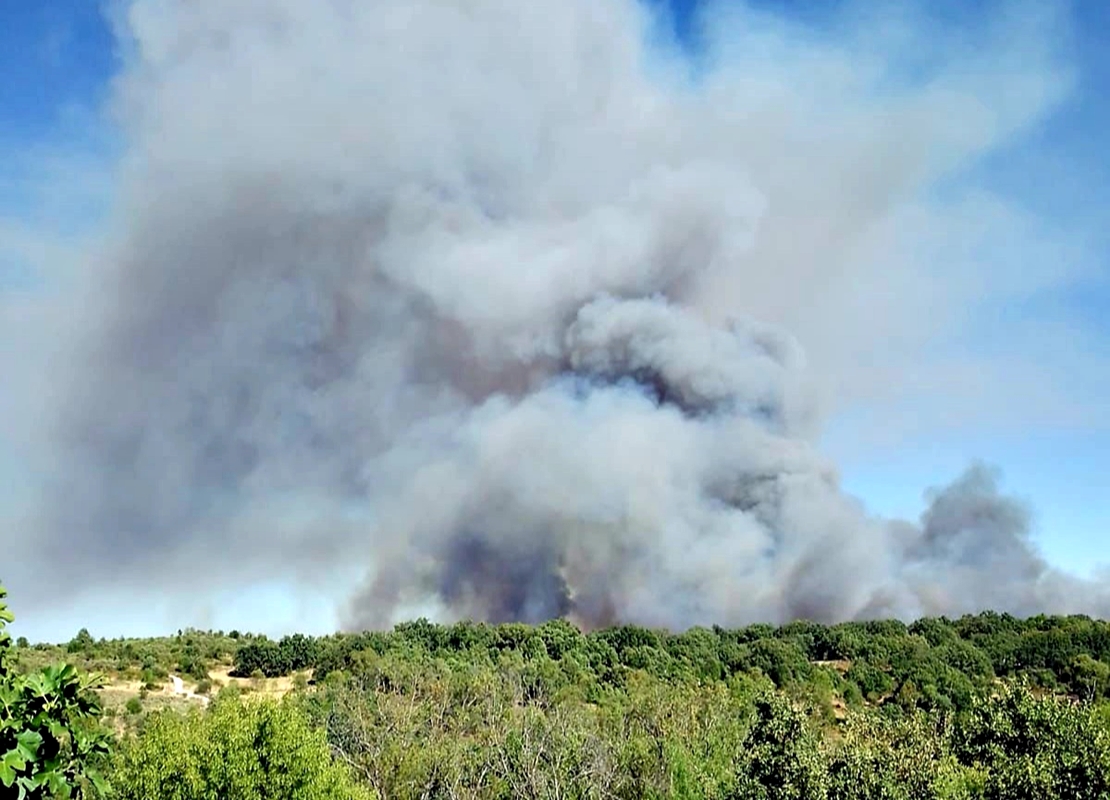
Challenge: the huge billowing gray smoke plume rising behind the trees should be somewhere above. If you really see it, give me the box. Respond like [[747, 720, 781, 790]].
[[10, 0, 1110, 627]]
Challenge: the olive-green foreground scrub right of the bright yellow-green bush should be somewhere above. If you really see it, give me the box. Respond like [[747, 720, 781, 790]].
[[284, 649, 1110, 800]]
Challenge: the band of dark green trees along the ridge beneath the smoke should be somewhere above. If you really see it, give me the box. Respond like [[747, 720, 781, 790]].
[[234, 612, 1110, 710]]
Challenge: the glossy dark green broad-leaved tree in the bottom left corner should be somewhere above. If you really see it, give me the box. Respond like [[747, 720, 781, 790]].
[[0, 586, 109, 800]]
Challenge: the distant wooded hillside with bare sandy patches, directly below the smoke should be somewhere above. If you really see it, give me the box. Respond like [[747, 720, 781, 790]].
[[17, 612, 1110, 710]]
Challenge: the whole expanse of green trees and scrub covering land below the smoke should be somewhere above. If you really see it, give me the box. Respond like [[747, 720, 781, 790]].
[[4, 581, 1110, 800]]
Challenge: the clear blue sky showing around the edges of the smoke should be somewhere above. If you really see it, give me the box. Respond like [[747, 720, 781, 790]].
[[0, 0, 1110, 638]]
